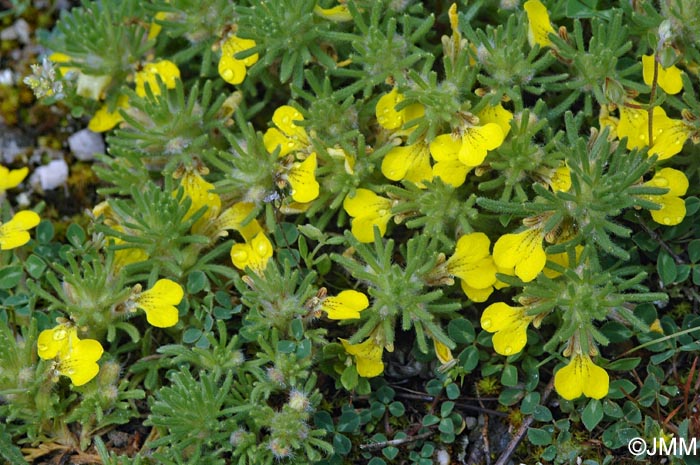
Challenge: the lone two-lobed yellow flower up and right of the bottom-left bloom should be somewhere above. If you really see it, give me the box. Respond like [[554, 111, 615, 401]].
[[134, 279, 184, 328]]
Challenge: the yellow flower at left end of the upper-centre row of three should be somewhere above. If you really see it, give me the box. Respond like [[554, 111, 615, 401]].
[[382, 142, 433, 187]]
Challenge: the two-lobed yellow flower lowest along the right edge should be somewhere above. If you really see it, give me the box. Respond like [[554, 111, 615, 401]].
[[644, 168, 688, 226]]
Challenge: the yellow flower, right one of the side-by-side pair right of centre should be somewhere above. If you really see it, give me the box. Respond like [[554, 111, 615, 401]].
[[493, 228, 547, 282]]
